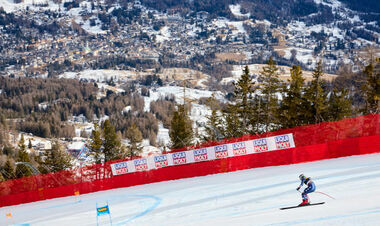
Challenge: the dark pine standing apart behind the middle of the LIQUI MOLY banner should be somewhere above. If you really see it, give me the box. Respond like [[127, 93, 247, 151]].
[[169, 105, 194, 149]]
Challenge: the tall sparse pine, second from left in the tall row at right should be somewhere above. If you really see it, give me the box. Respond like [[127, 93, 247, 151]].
[[259, 57, 282, 131]]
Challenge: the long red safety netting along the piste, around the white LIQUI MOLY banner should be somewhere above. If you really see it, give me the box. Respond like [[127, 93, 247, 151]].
[[0, 114, 380, 206]]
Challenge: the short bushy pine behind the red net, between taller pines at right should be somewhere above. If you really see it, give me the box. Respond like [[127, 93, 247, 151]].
[[328, 89, 352, 121]]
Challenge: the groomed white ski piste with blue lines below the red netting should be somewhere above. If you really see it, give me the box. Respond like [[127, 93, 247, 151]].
[[0, 154, 380, 226]]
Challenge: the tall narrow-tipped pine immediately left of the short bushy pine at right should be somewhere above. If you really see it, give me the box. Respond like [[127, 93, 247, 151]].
[[305, 60, 328, 124]]
